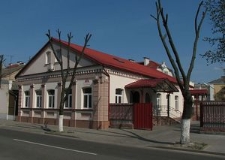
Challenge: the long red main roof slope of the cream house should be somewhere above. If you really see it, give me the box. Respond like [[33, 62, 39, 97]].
[[52, 38, 177, 83]]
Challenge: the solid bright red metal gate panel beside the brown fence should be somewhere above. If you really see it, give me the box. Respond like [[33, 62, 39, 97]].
[[133, 103, 152, 130]]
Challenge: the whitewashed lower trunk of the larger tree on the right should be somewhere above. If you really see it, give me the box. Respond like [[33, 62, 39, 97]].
[[180, 119, 191, 144]]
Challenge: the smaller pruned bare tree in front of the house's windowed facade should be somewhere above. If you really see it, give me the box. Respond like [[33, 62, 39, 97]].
[[46, 30, 92, 132]]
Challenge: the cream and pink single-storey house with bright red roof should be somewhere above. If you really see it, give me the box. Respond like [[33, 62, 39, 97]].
[[16, 39, 183, 129]]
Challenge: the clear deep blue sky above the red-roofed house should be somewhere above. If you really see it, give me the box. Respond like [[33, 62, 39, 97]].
[[0, 0, 224, 83]]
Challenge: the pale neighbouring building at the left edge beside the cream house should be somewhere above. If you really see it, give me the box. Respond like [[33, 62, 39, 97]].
[[0, 63, 24, 120]]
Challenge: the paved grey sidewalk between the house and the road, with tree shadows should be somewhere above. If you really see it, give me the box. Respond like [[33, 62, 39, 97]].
[[0, 120, 225, 156]]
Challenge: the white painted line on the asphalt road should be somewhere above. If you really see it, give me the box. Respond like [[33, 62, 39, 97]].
[[13, 139, 97, 156]]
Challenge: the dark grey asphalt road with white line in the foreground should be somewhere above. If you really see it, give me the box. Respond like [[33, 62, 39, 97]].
[[0, 129, 224, 160]]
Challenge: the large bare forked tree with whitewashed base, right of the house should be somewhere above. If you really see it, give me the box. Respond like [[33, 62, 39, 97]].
[[151, 0, 207, 144]]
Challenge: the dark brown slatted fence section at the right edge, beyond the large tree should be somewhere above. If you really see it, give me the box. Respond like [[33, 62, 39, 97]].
[[200, 101, 225, 128]]
